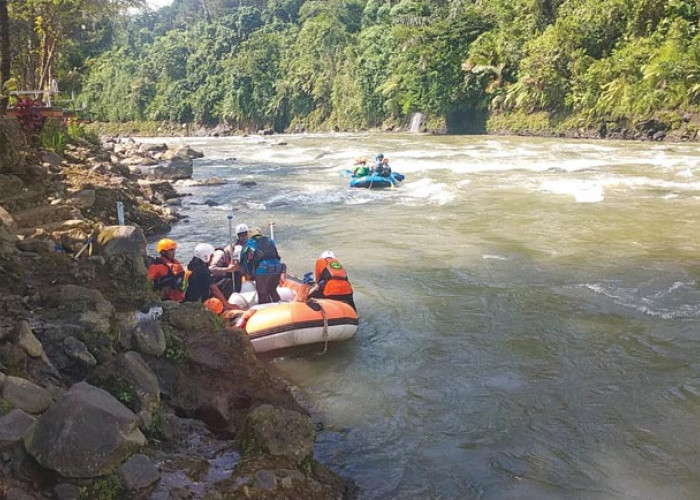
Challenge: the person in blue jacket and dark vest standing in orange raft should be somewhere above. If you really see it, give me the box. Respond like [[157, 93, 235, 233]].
[[241, 227, 286, 304]]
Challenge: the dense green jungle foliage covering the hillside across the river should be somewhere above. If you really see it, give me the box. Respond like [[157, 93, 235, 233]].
[[5, 0, 700, 132]]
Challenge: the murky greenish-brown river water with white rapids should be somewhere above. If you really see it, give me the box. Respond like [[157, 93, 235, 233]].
[[150, 134, 700, 500]]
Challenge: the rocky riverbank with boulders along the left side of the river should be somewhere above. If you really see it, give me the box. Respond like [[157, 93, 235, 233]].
[[0, 123, 356, 500]]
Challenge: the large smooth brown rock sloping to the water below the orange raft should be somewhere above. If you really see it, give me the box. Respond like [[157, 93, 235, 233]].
[[147, 304, 304, 433]]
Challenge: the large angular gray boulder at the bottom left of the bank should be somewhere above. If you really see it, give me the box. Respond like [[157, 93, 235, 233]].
[[25, 382, 146, 478]]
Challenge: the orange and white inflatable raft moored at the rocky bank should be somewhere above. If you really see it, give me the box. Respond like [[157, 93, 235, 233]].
[[224, 299, 359, 352]]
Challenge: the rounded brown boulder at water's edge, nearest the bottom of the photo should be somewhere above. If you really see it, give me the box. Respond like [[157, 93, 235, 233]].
[[243, 404, 316, 462]]
